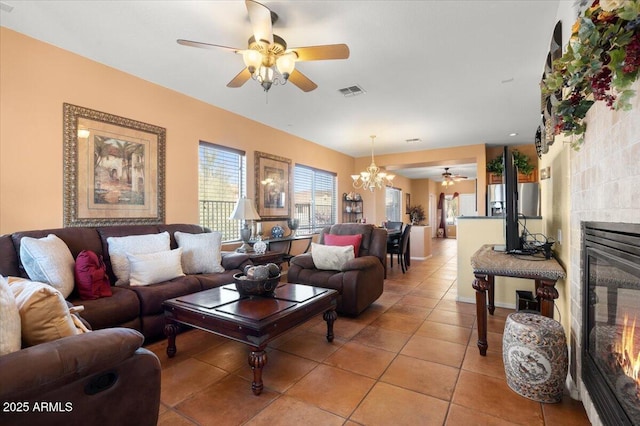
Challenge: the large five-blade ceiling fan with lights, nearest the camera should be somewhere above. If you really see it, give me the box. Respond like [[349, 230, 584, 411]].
[[178, 0, 349, 92]]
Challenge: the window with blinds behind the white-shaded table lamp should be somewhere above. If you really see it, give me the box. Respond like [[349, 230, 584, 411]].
[[198, 141, 247, 241]]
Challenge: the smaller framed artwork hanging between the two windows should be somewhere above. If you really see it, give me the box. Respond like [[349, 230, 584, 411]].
[[254, 151, 293, 220]]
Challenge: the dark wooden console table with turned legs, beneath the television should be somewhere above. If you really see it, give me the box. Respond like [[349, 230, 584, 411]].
[[471, 244, 566, 356]]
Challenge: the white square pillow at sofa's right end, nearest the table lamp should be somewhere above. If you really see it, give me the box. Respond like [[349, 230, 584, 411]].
[[173, 231, 224, 274]]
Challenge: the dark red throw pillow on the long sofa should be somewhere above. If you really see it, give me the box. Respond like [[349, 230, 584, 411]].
[[74, 250, 112, 300]]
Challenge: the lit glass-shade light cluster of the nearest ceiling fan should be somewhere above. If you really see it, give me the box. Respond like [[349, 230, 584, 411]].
[[242, 34, 298, 92]]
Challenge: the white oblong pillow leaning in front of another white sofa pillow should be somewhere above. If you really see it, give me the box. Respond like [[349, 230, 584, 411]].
[[127, 248, 184, 286]]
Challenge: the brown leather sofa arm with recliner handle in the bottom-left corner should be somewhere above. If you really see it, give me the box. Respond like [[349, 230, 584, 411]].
[[0, 328, 161, 426]]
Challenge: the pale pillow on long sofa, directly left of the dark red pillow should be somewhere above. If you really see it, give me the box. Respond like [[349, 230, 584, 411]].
[[20, 234, 75, 297]]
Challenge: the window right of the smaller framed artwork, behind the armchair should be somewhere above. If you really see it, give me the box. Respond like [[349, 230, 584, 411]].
[[293, 165, 337, 233]]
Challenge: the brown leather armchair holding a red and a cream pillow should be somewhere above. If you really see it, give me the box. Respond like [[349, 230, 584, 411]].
[[287, 223, 387, 315]]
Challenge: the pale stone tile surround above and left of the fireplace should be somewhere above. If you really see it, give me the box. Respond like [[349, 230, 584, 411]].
[[566, 82, 640, 425]]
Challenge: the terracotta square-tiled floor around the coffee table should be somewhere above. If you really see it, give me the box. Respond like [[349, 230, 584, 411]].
[[147, 239, 589, 426]]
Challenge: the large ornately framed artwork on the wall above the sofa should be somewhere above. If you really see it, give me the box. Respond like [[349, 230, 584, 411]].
[[63, 103, 166, 226]]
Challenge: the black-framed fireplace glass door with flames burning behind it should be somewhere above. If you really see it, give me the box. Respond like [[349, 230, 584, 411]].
[[582, 224, 640, 425]]
